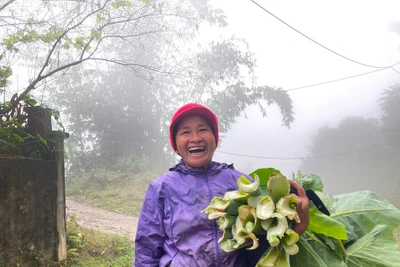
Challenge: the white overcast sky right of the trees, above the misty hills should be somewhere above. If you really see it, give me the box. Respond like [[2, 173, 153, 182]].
[[208, 0, 400, 176]]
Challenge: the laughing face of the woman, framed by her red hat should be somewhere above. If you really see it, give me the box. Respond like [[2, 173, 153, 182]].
[[175, 115, 216, 168]]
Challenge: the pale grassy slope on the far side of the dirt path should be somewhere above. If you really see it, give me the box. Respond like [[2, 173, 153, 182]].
[[66, 170, 158, 216]]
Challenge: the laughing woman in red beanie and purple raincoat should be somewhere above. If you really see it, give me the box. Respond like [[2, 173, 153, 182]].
[[134, 103, 309, 267]]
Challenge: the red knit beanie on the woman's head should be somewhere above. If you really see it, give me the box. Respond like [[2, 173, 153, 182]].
[[169, 103, 219, 151]]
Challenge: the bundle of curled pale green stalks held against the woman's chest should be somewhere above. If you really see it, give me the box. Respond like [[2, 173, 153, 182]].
[[203, 173, 308, 267]]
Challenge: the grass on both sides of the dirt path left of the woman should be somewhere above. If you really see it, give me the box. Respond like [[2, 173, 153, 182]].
[[63, 170, 159, 267]]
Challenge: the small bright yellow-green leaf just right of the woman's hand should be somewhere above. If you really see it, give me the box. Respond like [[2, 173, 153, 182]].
[[307, 208, 347, 240]]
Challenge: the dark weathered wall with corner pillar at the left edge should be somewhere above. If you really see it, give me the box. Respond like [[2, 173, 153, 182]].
[[0, 158, 60, 267]]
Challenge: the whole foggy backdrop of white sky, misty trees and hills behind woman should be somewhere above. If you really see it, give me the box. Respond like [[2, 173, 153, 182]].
[[2, 0, 400, 206]]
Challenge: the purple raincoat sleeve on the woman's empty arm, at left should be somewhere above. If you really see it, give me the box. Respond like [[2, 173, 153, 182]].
[[133, 183, 165, 267]]
